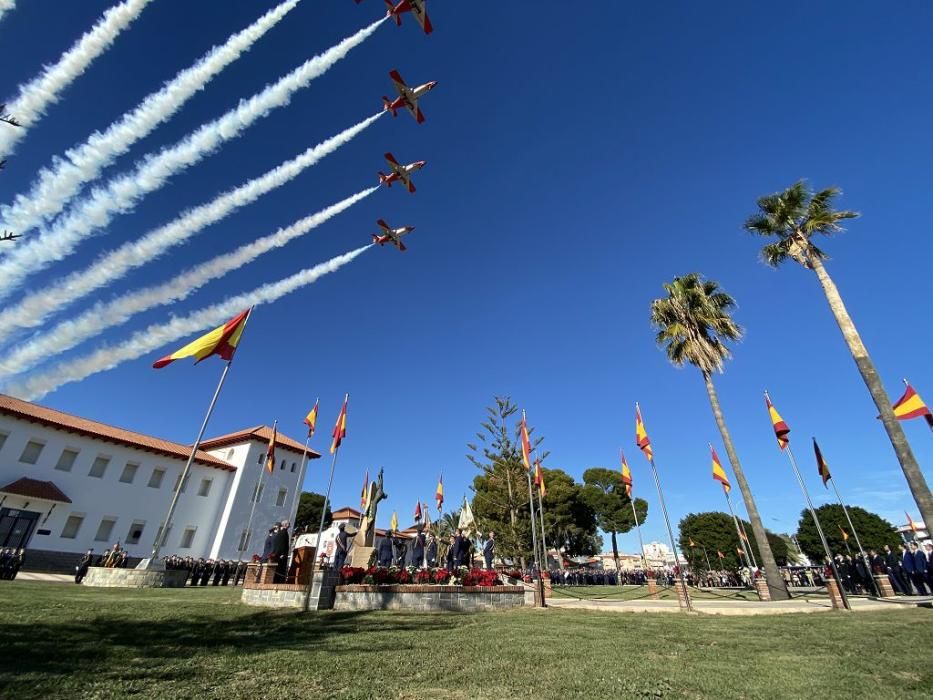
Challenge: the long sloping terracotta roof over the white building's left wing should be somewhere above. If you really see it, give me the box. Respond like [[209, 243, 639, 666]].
[[0, 394, 236, 471]]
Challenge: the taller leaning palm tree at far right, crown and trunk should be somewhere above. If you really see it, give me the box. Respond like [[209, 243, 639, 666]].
[[745, 180, 933, 523]]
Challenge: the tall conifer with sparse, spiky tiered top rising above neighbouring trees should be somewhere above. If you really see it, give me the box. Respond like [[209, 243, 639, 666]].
[[467, 396, 547, 565]]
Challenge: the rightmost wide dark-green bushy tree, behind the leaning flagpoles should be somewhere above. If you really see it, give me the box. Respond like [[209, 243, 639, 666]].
[[797, 503, 901, 562]]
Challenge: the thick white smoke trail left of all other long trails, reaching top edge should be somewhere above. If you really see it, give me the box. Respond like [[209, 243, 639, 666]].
[[0, 0, 151, 155]]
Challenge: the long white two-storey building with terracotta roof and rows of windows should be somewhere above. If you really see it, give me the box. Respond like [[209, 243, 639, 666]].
[[0, 394, 320, 564]]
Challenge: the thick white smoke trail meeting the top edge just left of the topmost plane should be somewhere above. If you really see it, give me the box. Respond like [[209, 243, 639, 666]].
[[0, 0, 300, 234]]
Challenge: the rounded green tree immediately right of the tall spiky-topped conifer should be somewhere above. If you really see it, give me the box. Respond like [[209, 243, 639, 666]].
[[535, 468, 602, 557]]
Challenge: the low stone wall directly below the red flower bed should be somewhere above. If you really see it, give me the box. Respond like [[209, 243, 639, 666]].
[[334, 584, 526, 612]]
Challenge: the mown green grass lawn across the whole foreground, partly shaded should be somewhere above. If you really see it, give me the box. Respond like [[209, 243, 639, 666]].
[[0, 581, 933, 700]]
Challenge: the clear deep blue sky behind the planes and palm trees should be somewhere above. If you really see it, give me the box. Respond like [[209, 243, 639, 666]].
[[0, 0, 933, 551]]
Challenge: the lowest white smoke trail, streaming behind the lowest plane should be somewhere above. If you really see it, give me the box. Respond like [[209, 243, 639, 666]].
[[7, 244, 372, 401]]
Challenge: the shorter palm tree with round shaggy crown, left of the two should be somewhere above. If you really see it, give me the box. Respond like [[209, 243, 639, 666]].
[[651, 272, 789, 599]]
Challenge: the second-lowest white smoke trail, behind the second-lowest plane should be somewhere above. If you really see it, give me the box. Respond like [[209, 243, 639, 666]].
[[0, 187, 379, 374]]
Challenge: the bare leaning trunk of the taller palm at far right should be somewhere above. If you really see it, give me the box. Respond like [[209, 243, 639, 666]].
[[809, 255, 933, 528]]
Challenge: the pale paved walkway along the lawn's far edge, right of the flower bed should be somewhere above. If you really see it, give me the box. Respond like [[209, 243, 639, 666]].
[[548, 596, 933, 615]]
